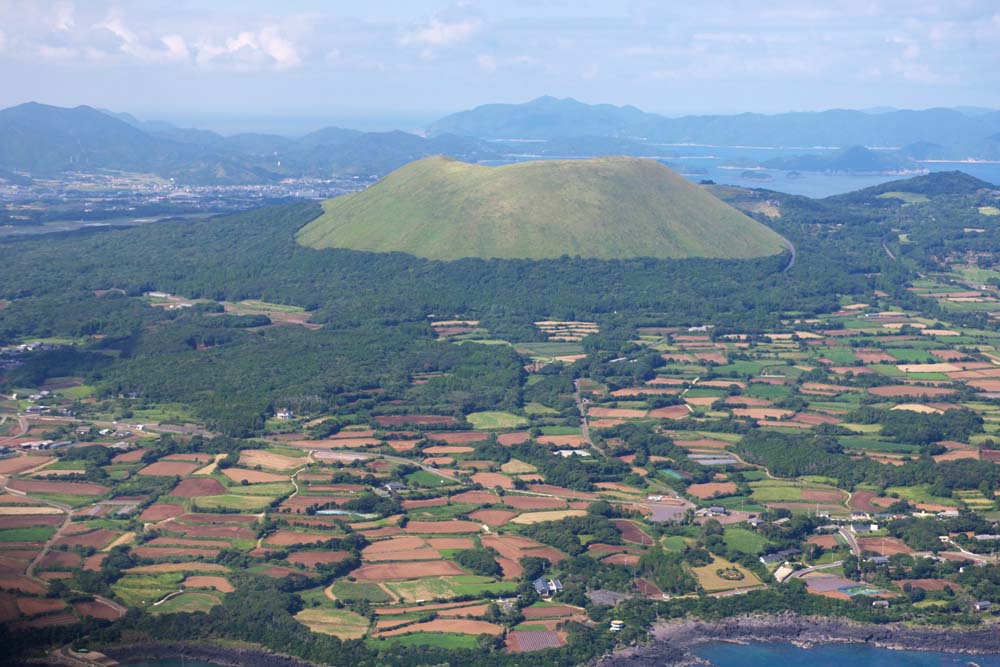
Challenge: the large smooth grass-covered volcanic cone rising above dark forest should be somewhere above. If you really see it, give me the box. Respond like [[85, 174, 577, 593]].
[[296, 156, 783, 260]]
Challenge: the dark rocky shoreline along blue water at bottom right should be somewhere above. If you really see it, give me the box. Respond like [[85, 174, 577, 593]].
[[598, 614, 1000, 667]]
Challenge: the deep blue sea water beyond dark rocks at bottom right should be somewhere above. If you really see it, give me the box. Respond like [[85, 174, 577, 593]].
[[695, 643, 1000, 667]]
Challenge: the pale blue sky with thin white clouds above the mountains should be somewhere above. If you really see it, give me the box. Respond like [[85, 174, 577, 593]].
[[0, 0, 1000, 130]]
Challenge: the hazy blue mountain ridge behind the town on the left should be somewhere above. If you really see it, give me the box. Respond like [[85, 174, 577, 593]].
[[0, 102, 498, 184]]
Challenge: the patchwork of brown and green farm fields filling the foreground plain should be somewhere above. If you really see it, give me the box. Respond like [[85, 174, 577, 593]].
[[9, 206, 1000, 664]]
